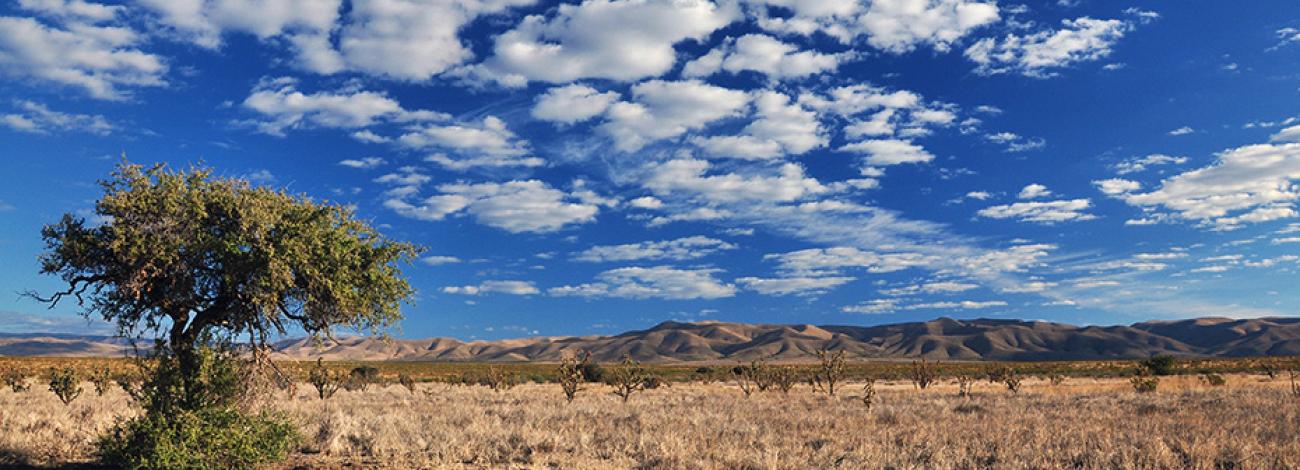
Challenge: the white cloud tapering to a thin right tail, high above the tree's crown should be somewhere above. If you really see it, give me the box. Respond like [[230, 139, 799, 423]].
[[243, 78, 449, 136]]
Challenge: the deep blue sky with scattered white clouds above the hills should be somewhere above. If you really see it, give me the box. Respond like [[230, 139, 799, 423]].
[[0, 0, 1300, 339]]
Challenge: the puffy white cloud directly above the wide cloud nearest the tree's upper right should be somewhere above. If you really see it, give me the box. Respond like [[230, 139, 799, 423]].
[[398, 116, 546, 170]]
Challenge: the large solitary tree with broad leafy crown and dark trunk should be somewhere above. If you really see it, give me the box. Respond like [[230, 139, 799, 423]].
[[30, 162, 419, 400]]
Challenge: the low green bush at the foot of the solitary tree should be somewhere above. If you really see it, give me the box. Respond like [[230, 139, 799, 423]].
[[99, 408, 300, 469]]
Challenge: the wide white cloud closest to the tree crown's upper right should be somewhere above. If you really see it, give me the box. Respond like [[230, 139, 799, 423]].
[[384, 179, 599, 234]]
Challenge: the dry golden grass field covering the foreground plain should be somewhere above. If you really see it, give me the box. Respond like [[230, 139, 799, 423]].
[[0, 358, 1300, 469]]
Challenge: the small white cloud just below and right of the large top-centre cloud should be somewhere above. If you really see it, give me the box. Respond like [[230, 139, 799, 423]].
[[681, 34, 849, 80]]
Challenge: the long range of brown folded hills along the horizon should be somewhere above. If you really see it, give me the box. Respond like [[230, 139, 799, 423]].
[[0, 318, 1300, 364]]
